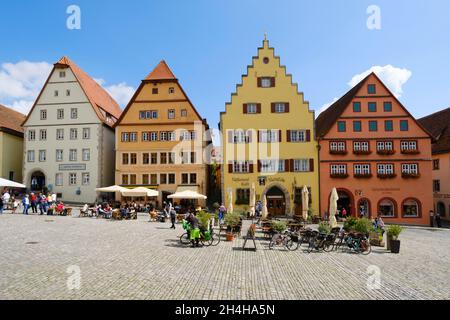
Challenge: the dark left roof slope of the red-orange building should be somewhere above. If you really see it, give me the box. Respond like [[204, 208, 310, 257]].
[[316, 74, 370, 138]]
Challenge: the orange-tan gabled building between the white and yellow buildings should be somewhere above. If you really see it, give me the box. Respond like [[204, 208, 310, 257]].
[[115, 61, 210, 205]]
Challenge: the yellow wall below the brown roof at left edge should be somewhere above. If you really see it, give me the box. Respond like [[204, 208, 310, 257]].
[[0, 130, 23, 183]]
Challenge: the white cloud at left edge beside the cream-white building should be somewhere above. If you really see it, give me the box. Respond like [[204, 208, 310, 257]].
[[0, 61, 52, 113]]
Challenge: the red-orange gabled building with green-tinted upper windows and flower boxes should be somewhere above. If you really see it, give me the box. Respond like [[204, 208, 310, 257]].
[[316, 73, 433, 225]]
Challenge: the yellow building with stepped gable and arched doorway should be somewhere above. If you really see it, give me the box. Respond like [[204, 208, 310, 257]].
[[220, 40, 319, 216]]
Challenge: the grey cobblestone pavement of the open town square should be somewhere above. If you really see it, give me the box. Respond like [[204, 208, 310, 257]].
[[0, 214, 450, 300]]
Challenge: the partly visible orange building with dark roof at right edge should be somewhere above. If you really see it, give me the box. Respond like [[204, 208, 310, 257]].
[[419, 108, 450, 221]]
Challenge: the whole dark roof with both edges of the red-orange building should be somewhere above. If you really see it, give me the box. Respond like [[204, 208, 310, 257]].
[[316, 72, 434, 140]]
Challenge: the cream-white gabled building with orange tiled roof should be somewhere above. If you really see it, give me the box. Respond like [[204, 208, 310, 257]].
[[23, 57, 121, 203]]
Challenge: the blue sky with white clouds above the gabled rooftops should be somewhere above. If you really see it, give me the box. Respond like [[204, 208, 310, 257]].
[[0, 0, 450, 144]]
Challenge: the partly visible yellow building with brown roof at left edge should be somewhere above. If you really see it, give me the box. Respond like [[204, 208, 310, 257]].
[[0, 105, 25, 182]]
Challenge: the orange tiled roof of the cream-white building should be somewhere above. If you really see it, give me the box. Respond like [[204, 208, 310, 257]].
[[24, 57, 122, 127]]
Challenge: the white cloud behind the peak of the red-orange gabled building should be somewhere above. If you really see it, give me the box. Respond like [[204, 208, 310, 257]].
[[348, 64, 412, 98]]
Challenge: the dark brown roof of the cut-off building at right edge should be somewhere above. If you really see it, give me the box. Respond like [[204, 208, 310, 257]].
[[418, 108, 450, 154]]
